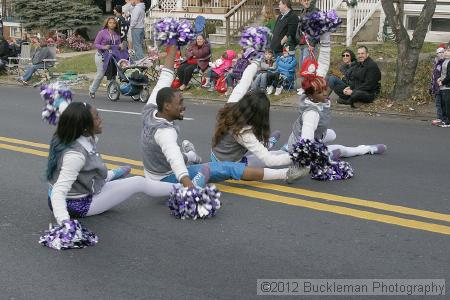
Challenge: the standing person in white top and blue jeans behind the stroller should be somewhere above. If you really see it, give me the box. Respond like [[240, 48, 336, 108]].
[[130, 0, 145, 60]]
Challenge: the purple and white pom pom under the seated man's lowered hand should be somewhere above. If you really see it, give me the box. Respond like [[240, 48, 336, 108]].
[[167, 184, 221, 220]]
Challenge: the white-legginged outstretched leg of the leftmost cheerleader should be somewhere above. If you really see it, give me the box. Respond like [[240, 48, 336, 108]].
[[87, 176, 173, 216]]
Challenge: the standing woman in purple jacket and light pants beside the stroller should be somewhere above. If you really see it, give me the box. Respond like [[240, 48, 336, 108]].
[[89, 17, 123, 99]]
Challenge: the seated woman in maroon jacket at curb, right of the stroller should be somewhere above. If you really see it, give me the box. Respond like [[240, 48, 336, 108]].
[[177, 35, 211, 91]]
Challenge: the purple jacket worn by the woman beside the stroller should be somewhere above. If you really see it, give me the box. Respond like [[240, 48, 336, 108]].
[[94, 28, 128, 72]]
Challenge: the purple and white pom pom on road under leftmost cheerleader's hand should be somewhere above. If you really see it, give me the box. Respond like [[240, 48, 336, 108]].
[[39, 220, 98, 250]]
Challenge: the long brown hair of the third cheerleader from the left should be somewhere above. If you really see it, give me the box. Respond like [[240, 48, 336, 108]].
[[212, 91, 270, 147]]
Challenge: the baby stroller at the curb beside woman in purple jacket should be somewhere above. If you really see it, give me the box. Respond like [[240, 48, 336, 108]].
[[106, 57, 150, 102]]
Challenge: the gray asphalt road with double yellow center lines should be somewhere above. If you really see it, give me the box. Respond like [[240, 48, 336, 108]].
[[0, 87, 450, 299]]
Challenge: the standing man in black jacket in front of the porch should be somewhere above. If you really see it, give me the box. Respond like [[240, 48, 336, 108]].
[[270, 0, 298, 58]]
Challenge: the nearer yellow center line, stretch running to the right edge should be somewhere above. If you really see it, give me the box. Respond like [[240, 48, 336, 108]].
[[216, 184, 450, 235]]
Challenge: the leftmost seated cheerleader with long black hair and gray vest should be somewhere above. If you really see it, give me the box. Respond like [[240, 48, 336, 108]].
[[47, 102, 173, 224]]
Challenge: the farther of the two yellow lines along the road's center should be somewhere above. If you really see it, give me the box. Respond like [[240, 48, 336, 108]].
[[0, 136, 450, 222]]
